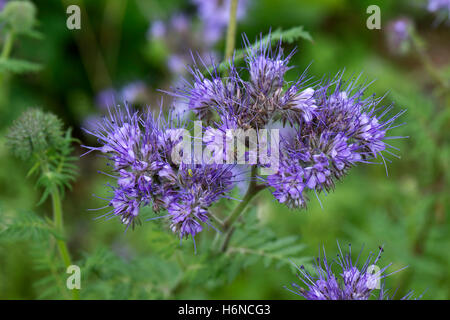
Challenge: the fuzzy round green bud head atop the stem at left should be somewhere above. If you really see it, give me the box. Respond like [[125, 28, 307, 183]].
[[6, 109, 65, 160]]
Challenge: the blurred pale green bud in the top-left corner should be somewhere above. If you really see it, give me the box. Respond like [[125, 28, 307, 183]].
[[0, 1, 36, 34]]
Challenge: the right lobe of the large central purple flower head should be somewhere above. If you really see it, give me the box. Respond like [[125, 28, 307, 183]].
[[267, 74, 401, 208]]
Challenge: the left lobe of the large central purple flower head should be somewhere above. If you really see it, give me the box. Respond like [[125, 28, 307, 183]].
[[86, 107, 234, 238]]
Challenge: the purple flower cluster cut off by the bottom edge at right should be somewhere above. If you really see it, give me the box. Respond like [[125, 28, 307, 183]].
[[286, 244, 413, 300]]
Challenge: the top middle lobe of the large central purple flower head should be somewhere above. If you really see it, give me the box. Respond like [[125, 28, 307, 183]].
[[171, 36, 317, 130]]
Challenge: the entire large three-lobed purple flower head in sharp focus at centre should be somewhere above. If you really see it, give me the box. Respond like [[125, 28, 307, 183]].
[[86, 34, 399, 242]]
